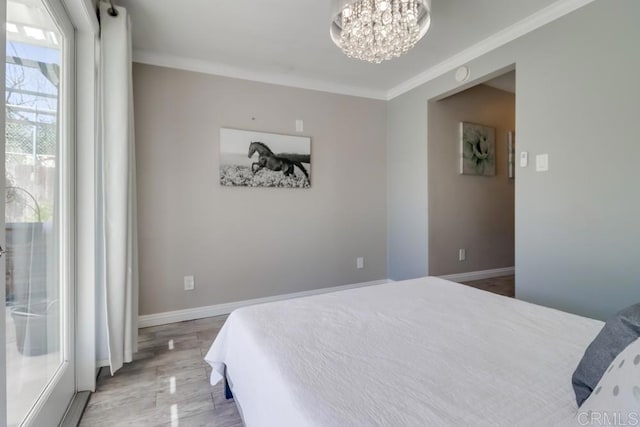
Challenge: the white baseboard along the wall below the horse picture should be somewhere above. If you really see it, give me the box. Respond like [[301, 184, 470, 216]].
[[138, 279, 389, 328]]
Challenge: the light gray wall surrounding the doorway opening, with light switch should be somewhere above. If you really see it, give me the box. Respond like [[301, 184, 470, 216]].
[[387, 0, 640, 318]]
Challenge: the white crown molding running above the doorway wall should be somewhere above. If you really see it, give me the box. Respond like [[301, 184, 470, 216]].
[[386, 0, 595, 100]]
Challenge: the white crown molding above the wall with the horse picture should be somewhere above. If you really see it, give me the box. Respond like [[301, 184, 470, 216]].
[[133, 50, 387, 101]]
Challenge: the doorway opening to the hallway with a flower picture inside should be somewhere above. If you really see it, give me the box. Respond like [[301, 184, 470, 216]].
[[428, 70, 516, 297]]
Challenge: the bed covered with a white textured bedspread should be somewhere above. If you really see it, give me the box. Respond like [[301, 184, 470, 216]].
[[205, 277, 603, 426]]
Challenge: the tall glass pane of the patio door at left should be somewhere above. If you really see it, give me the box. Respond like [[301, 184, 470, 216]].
[[5, 0, 63, 426]]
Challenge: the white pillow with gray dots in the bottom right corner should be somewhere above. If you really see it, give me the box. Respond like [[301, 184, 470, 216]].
[[577, 338, 640, 426]]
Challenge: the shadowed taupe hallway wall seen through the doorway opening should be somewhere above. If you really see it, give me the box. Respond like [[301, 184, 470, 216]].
[[428, 85, 516, 276]]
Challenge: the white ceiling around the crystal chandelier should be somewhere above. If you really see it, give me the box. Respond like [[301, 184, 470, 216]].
[[117, 0, 589, 99]]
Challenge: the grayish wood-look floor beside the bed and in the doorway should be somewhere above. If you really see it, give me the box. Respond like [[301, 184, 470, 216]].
[[80, 276, 515, 427]]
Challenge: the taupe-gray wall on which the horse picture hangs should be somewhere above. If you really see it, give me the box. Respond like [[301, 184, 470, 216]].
[[134, 64, 387, 314]]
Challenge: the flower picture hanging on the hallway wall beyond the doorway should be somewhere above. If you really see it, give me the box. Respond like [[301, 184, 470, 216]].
[[460, 122, 496, 176]]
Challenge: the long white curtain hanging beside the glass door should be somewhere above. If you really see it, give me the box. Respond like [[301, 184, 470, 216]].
[[97, 3, 138, 374]]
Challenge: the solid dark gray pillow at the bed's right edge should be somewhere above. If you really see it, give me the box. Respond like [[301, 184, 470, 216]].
[[571, 304, 640, 406]]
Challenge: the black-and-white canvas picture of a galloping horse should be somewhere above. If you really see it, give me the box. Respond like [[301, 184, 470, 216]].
[[220, 128, 311, 188]]
